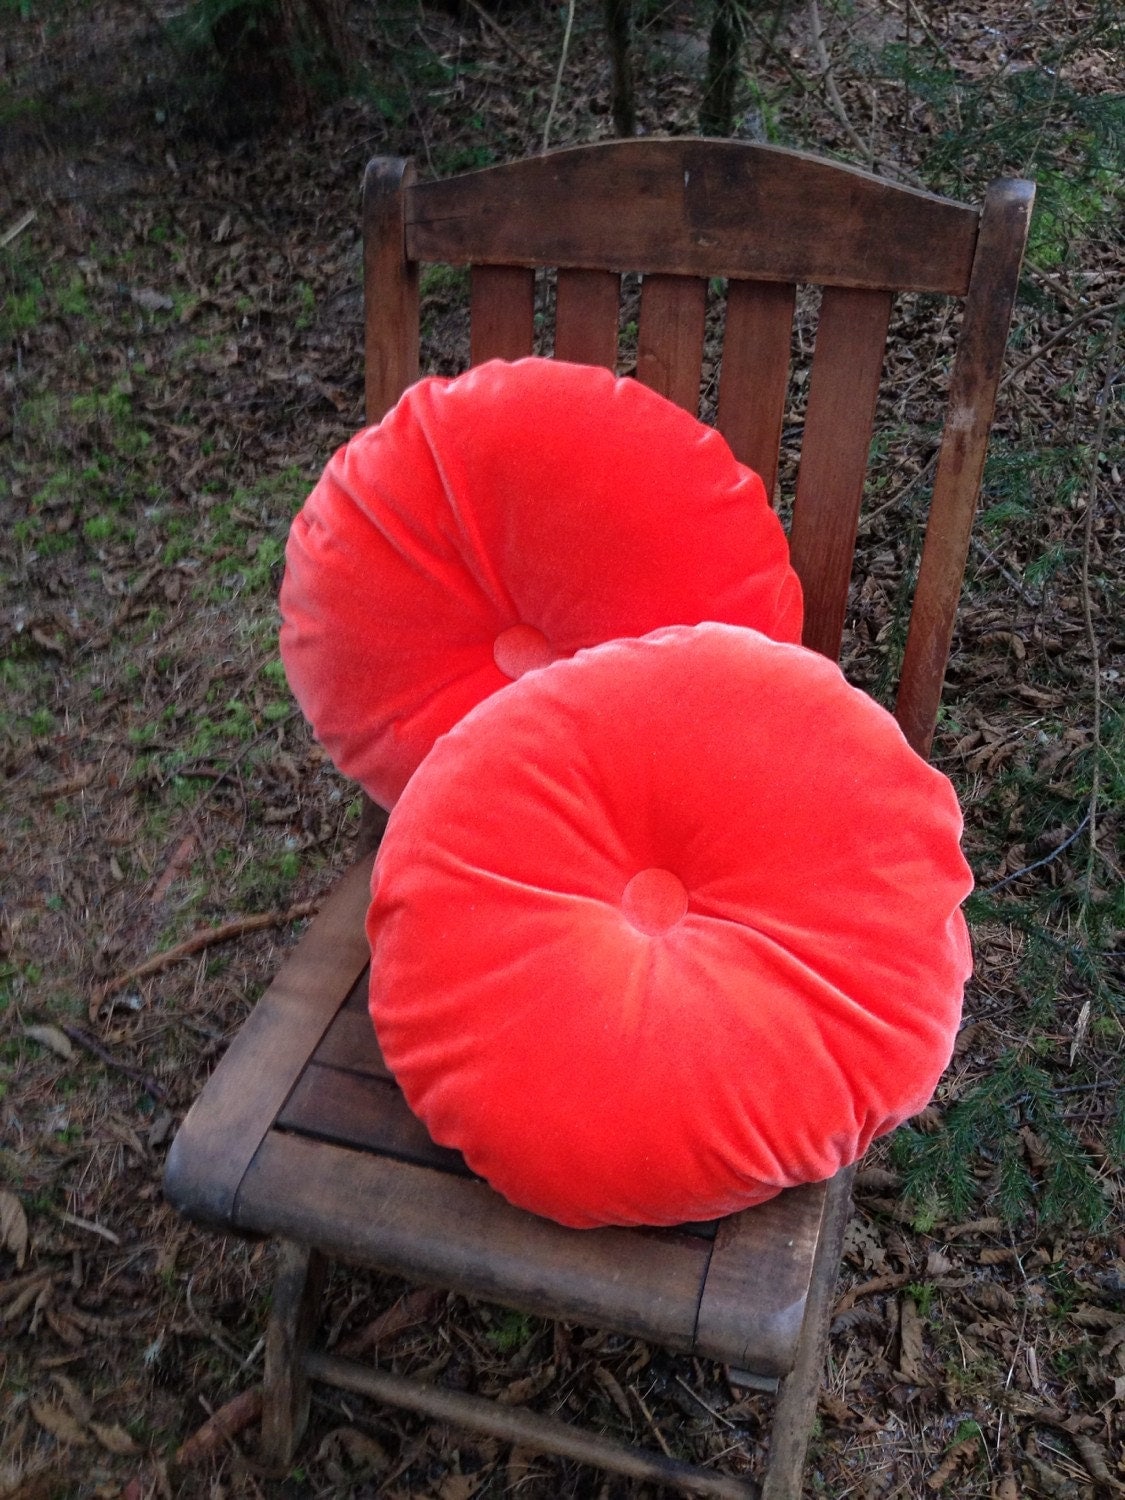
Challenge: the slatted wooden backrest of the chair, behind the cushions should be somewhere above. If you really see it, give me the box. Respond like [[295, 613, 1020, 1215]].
[[365, 138, 1035, 755]]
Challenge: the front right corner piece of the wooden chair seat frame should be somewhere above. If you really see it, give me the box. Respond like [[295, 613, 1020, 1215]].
[[696, 1182, 825, 1376]]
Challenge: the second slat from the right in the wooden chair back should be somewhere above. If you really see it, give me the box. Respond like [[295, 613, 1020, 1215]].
[[716, 281, 797, 500]]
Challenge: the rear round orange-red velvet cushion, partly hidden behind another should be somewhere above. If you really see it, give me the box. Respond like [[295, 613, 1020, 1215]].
[[281, 359, 801, 807]]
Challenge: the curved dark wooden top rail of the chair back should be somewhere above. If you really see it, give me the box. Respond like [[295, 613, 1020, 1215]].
[[407, 138, 977, 296]]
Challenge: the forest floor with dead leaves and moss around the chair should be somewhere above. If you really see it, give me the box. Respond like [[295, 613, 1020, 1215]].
[[0, 0, 1125, 1500]]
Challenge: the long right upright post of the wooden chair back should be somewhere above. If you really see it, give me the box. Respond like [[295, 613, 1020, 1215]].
[[896, 180, 1035, 755]]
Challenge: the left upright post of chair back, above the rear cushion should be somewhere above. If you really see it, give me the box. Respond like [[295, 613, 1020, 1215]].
[[363, 156, 419, 422]]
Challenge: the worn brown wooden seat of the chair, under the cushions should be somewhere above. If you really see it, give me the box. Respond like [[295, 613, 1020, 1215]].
[[165, 857, 827, 1382]]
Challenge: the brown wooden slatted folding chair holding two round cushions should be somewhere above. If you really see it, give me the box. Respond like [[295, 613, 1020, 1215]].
[[165, 140, 1034, 1497]]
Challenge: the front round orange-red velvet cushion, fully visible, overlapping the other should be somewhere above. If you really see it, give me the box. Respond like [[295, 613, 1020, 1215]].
[[368, 624, 972, 1227]]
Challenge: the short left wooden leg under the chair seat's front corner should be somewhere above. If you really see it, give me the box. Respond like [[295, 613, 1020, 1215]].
[[261, 1239, 326, 1469]]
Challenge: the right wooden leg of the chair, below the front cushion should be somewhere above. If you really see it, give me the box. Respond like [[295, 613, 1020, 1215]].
[[762, 1167, 855, 1500]]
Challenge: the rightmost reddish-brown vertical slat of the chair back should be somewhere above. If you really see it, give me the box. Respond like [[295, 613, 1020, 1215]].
[[789, 287, 891, 660]]
